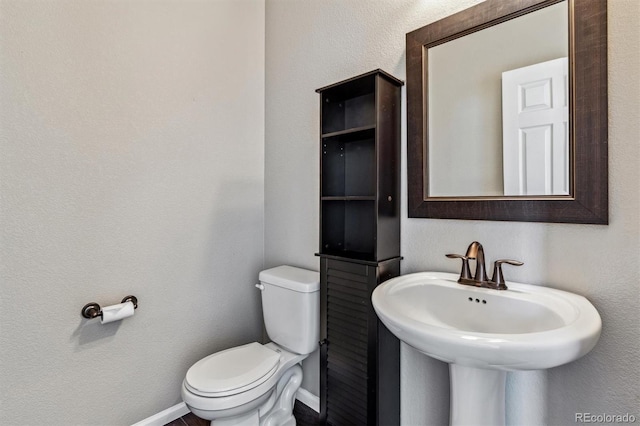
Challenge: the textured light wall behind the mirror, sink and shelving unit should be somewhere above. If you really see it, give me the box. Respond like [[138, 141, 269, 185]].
[[265, 0, 640, 425]]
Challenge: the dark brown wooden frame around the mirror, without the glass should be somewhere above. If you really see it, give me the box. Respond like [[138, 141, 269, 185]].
[[407, 0, 609, 224]]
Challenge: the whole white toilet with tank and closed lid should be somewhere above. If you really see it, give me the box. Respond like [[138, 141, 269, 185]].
[[182, 266, 320, 426]]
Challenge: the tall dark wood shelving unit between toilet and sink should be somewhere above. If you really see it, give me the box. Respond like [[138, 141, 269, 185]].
[[317, 70, 404, 426]]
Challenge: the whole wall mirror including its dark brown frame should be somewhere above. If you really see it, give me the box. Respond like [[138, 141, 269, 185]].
[[407, 0, 608, 224]]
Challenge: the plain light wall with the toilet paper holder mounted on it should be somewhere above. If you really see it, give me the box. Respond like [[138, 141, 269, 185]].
[[0, 0, 264, 425]]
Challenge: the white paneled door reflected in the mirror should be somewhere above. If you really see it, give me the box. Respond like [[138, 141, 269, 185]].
[[502, 57, 569, 196]]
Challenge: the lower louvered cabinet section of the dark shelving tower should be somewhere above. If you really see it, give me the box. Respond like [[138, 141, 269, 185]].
[[320, 258, 400, 426]]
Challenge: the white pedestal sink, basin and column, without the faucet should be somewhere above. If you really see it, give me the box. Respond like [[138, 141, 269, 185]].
[[372, 272, 602, 426]]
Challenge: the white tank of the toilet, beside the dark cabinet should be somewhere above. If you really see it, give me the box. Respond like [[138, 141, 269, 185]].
[[258, 266, 320, 354]]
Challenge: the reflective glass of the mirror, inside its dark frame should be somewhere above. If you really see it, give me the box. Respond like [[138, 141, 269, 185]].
[[425, 1, 572, 198]]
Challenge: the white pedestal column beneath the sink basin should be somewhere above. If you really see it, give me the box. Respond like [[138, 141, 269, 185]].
[[449, 364, 507, 426]]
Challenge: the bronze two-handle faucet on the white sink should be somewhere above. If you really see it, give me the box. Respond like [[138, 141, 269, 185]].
[[446, 241, 524, 290]]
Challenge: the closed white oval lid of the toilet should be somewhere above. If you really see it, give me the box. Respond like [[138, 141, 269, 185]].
[[186, 342, 280, 394]]
